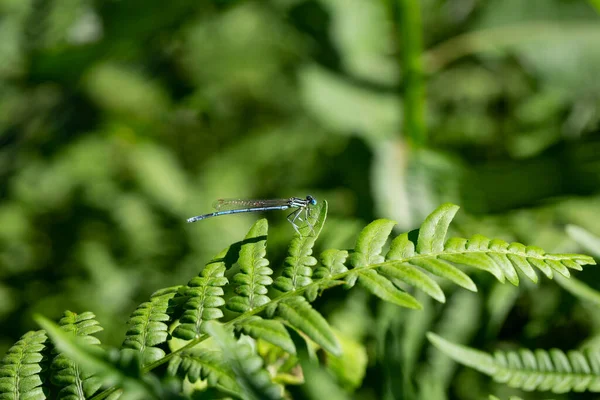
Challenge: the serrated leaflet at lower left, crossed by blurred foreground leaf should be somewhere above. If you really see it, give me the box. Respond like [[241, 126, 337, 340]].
[[51, 311, 103, 400]]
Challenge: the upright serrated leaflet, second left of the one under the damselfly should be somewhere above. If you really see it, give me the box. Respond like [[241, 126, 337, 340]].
[[173, 249, 229, 340]]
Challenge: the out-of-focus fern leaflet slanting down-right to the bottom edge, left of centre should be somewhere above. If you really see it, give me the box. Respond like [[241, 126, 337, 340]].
[[206, 321, 283, 400]]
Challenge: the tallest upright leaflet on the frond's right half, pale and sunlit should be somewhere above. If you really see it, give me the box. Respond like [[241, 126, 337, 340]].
[[417, 203, 460, 254]]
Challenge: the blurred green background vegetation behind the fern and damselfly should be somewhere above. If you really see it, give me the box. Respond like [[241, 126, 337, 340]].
[[0, 0, 600, 399]]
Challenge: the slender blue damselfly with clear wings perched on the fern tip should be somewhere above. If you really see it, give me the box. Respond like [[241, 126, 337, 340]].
[[187, 195, 317, 235]]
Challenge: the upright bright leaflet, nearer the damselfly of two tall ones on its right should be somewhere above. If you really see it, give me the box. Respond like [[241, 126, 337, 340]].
[[350, 219, 396, 268]]
